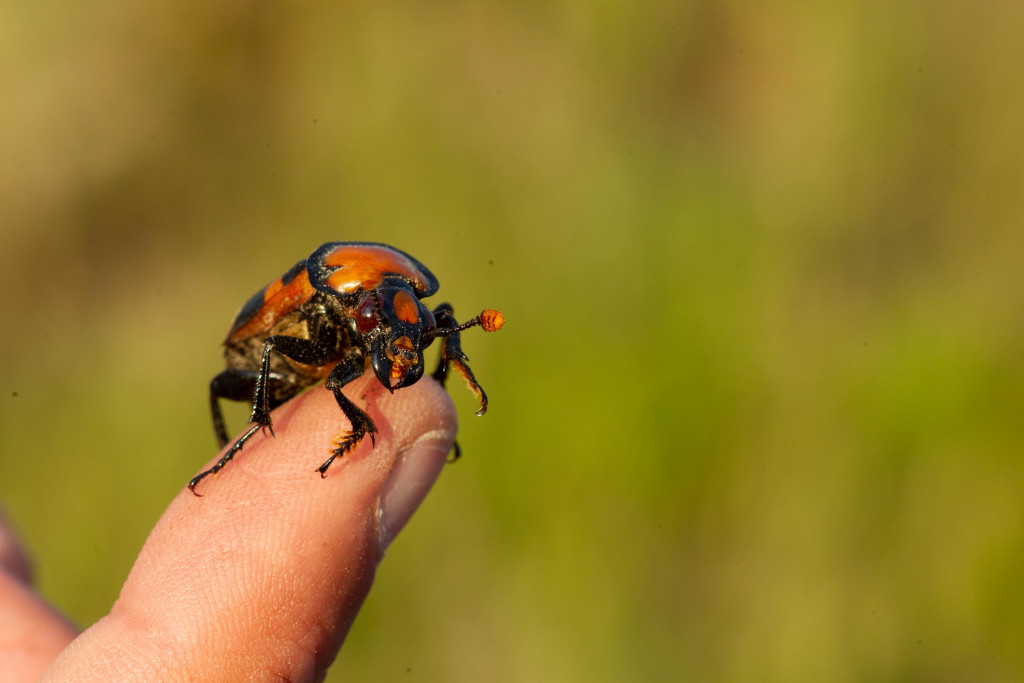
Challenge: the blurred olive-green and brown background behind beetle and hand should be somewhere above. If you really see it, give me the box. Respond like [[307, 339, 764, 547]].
[[0, 0, 1024, 682]]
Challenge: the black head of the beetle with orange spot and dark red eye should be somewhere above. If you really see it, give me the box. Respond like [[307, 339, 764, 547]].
[[355, 281, 436, 391]]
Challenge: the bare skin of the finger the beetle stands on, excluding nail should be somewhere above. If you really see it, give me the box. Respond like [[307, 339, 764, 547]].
[[43, 378, 456, 681]]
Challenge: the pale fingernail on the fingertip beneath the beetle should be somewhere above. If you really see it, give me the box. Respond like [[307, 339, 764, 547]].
[[377, 431, 452, 553]]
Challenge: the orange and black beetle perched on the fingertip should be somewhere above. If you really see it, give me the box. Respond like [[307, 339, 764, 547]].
[[188, 242, 505, 496]]
